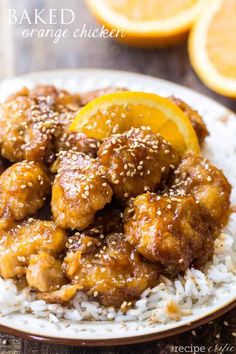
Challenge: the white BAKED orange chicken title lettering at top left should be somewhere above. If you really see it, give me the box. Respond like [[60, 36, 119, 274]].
[[8, 8, 126, 44]]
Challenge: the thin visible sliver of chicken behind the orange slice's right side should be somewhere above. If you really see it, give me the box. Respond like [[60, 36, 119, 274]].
[[169, 96, 209, 145]]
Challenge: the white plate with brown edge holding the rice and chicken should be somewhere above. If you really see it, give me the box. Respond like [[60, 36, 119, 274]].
[[0, 69, 236, 346]]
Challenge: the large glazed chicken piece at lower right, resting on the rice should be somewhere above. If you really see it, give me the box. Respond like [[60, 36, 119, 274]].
[[124, 193, 213, 275]]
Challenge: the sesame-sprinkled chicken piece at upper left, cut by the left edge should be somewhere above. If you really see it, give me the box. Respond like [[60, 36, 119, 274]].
[[0, 88, 56, 162]]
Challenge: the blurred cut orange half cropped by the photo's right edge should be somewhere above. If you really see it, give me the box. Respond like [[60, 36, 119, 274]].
[[189, 0, 236, 98]]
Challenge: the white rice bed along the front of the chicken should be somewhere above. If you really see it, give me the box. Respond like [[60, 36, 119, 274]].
[[0, 217, 236, 323]]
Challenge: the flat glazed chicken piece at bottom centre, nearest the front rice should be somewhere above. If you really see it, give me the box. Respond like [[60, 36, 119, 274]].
[[63, 233, 160, 308]]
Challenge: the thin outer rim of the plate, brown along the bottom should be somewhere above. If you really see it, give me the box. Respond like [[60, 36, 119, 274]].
[[0, 67, 236, 347]]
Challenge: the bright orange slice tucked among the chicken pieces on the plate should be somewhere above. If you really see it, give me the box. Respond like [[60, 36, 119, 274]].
[[70, 92, 200, 154]]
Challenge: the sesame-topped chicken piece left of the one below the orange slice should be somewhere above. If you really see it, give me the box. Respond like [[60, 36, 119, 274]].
[[51, 151, 112, 230]]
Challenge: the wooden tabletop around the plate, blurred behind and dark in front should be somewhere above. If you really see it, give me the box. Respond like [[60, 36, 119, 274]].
[[0, 0, 236, 354]]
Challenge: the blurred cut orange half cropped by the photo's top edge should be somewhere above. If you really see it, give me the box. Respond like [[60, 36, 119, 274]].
[[86, 0, 208, 47]]
